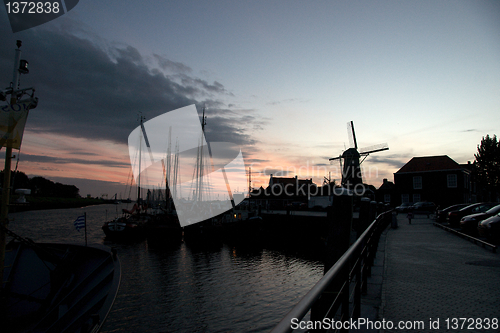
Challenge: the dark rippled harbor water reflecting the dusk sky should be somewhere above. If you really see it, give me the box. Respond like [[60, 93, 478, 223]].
[[9, 205, 323, 333]]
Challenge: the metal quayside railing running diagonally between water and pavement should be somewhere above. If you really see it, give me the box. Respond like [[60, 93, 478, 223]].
[[271, 210, 392, 333]]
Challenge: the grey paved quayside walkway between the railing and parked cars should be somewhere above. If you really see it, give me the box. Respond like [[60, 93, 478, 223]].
[[378, 214, 500, 332]]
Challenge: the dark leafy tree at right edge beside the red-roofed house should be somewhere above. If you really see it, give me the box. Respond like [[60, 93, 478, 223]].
[[474, 135, 500, 200]]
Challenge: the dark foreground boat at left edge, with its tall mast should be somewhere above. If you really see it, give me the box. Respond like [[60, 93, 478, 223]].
[[0, 40, 121, 333]]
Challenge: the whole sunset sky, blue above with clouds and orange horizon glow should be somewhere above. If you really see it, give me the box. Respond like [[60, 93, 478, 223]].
[[0, 0, 500, 197]]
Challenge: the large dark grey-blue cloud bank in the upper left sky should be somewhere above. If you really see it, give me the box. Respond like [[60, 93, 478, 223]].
[[0, 19, 260, 145]]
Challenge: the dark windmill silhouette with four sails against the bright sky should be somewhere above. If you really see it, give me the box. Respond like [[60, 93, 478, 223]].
[[329, 121, 389, 189]]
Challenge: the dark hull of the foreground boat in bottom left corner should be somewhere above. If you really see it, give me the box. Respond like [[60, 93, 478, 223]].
[[0, 242, 121, 333]]
